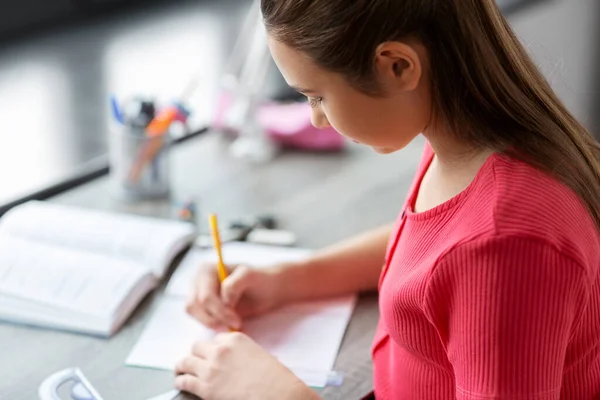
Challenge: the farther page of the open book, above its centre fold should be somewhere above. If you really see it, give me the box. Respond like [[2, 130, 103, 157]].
[[0, 201, 194, 276]]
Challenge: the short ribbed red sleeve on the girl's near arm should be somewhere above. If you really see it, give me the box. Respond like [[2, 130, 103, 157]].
[[424, 237, 587, 400]]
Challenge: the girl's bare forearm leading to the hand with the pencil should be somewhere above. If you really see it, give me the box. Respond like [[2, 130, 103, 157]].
[[280, 224, 393, 302]]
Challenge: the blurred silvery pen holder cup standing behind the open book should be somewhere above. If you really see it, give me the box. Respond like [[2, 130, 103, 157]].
[[110, 125, 171, 202]]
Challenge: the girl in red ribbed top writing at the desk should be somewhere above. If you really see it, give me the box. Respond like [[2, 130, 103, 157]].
[[176, 0, 600, 400]]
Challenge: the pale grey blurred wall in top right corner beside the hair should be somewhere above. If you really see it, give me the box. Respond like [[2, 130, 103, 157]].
[[509, 0, 600, 136]]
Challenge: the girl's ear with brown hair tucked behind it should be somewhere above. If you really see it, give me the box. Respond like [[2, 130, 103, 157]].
[[375, 42, 423, 93]]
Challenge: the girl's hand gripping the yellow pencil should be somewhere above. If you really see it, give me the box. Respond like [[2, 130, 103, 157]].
[[186, 264, 282, 330]]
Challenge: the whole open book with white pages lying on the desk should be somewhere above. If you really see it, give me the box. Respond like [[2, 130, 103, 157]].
[[0, 201, 195, 337]]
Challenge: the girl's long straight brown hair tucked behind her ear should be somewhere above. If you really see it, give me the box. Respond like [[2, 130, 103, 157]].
[[261, 0, 600, 227]]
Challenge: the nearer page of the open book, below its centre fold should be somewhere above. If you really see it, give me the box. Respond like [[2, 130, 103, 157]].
[[0, 235, 148, 317]]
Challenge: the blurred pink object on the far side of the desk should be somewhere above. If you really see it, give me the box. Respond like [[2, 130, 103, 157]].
[[213, 93, 346, 151]]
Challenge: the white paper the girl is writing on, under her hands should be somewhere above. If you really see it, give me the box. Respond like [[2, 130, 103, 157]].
[[126, 243, 356, 387]]
